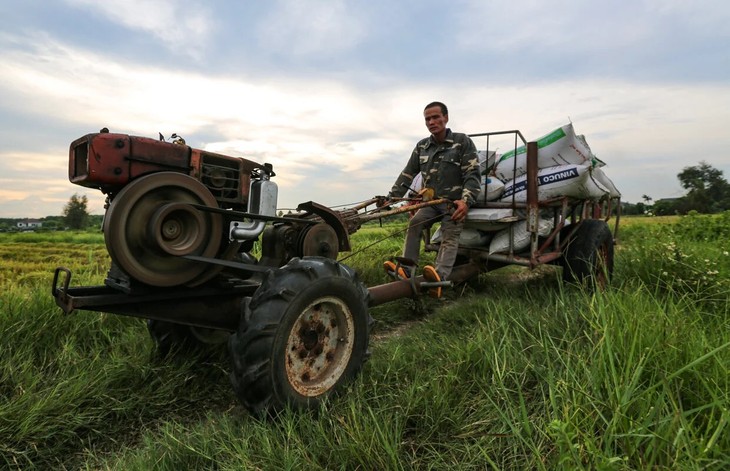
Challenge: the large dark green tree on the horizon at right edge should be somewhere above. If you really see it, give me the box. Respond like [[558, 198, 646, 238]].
[[677, 161, 730, 213]]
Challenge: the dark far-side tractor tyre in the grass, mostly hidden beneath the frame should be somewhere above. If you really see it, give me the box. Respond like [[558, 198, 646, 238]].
[[147, 319, 230, 357]]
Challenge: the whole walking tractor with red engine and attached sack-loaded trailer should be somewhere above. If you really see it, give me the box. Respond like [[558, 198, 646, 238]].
[[52, 126, 619, 413]]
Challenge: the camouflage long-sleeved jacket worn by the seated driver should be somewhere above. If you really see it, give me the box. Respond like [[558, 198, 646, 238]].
[[389, 129, 480, 206]]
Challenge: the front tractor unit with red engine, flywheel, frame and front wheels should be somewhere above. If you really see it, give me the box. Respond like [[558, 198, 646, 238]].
[[56, 129, 366, 412]]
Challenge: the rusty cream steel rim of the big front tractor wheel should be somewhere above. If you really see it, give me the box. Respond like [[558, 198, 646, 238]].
[[285, 296, 355, 397]]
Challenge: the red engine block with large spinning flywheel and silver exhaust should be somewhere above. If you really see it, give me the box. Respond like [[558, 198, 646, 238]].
[[69, 129, 278, 292]]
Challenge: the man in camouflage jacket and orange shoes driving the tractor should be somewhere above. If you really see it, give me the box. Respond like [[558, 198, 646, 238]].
[[383, 101, 479, 297]]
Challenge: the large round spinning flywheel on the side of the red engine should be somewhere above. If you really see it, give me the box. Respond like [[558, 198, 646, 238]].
[[104, 172, 222, 287]]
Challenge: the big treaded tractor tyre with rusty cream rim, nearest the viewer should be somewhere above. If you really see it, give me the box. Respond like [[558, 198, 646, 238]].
[[229, 257, 371, 414]]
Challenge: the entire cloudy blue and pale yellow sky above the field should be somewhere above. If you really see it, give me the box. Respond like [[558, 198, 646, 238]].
[[0, 0, 730, 218]]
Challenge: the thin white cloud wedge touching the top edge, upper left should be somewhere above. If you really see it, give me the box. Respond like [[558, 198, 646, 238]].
[[65, 0, 214, 57]]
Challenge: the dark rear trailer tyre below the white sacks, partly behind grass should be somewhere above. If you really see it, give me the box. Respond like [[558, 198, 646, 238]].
[[563, 219, 613, 289]]
